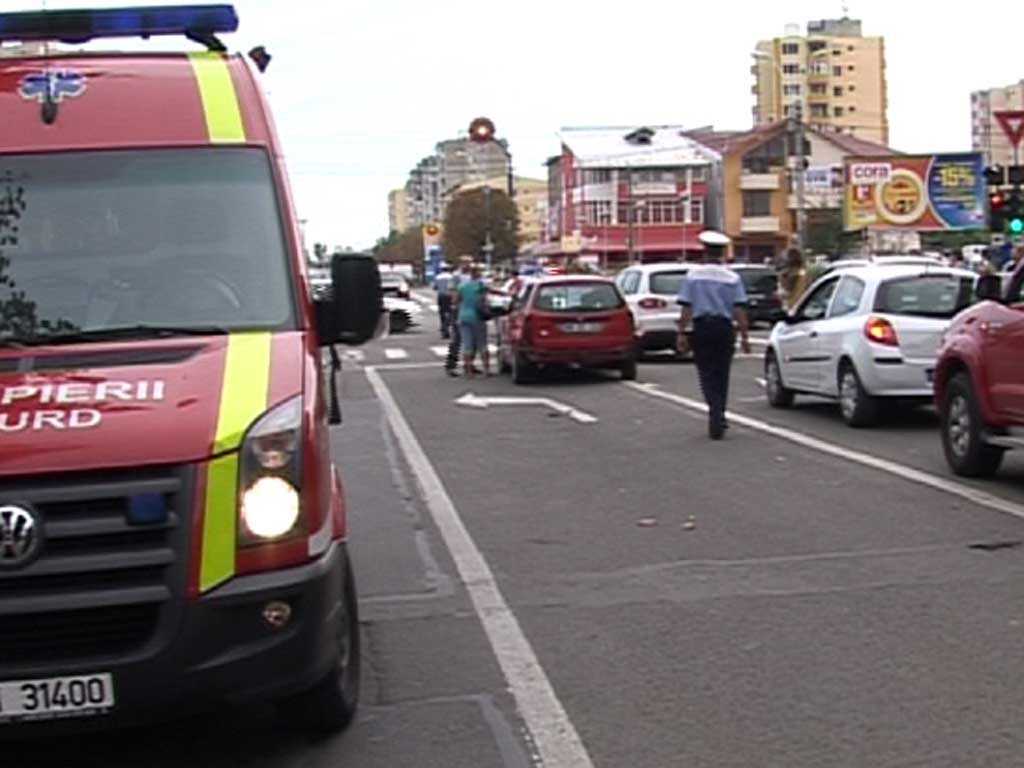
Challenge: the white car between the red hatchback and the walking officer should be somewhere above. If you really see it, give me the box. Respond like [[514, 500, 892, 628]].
[[615, 262, 690, 352]]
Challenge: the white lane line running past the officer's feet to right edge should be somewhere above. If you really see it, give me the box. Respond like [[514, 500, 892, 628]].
[[623, 381, 1024, 519]]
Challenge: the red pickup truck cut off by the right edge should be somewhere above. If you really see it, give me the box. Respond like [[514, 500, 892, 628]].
[[935, 263, 1024, 477]]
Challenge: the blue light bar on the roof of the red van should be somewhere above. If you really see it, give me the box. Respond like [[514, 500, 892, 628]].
[[0, 5, 239, 47]]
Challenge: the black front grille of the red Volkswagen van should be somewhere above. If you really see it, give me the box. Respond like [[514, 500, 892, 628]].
[[0, 469, 191, 677]]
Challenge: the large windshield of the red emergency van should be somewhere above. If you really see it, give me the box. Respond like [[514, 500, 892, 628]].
[[0, 147, 296, 343]]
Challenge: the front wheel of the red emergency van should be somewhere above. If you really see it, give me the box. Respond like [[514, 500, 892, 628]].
[[279, 558, 361, 733]]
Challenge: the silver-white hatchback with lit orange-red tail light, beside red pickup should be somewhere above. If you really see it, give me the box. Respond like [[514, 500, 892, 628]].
[[765, 264, 978, 427]]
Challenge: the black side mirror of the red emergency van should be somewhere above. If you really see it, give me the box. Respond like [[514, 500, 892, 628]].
[[315, 253, 387, 346]]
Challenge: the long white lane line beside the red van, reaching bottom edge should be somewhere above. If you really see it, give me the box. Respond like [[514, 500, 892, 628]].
[[366, 367, 594, 768]]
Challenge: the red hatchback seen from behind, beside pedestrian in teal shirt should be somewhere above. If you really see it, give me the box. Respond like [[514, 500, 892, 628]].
[[498, 275, 637, 384]]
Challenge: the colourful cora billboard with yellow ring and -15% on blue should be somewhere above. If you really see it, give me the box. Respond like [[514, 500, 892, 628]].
[[843, 153, 988, 231]]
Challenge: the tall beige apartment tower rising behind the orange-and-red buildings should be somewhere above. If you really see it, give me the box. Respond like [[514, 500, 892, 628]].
[[751, 18, 889, 144]]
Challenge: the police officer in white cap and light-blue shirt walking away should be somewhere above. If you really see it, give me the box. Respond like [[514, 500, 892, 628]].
[[678, 230, 751, 440]]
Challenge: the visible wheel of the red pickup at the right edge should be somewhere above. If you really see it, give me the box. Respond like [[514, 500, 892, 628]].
[[939, 374, 1004, 477]]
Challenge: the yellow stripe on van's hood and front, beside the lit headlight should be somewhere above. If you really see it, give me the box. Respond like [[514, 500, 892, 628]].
[[199, 333, 272, 592]]
